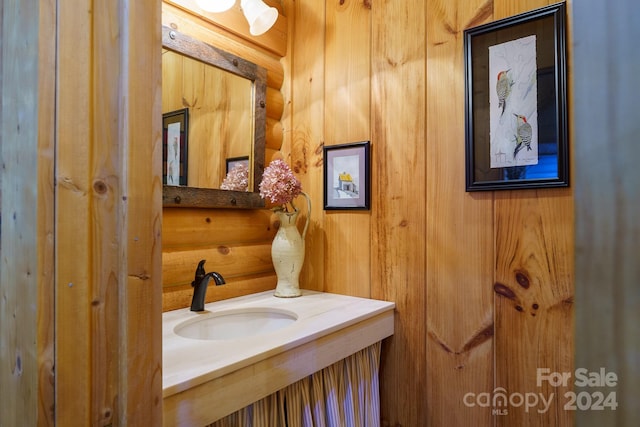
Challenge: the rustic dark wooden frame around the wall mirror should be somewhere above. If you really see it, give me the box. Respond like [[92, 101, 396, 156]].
[[162, 26, 267, 209]]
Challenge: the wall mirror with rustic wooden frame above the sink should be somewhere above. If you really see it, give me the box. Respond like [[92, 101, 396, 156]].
[[162, 26, 266, 208]]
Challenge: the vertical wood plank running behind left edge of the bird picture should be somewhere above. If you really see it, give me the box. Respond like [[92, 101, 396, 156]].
[[425, 0, 494, 427]]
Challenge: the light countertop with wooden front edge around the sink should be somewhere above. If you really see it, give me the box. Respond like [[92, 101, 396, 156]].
[[162, 290, 395, 425]]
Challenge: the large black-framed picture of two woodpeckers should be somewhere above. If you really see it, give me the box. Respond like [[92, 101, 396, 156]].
[[464, 3, 569, 191]]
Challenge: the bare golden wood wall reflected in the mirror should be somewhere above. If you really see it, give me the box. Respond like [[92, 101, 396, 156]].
[[162, 50, 253, 190]]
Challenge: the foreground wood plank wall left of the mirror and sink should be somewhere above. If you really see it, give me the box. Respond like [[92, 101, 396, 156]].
[[0, 0, 162, 426]]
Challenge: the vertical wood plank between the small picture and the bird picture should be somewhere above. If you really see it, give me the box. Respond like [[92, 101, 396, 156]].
[[371, 0, 429, 426]]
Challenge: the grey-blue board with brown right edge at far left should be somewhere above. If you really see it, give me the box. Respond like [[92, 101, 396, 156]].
[[0, 1, 55, 426]]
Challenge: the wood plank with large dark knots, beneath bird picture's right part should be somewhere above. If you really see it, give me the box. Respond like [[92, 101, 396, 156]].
[[494, 0, 574, 426]]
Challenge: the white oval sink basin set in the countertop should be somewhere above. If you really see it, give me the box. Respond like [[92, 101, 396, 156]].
[[173, 307, 298, 341]]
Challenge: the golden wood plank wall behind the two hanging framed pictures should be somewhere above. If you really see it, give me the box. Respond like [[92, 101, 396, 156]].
[[282, 0, 574, 426]]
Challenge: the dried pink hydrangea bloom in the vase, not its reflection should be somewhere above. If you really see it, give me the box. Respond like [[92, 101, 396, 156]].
[[260, 159, 302, 211]]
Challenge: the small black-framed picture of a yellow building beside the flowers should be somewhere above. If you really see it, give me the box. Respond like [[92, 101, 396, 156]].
[[323, 141, 371, 210]]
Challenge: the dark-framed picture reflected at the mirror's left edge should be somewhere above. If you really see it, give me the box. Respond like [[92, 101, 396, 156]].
[[162, 108, 189, 186]]
